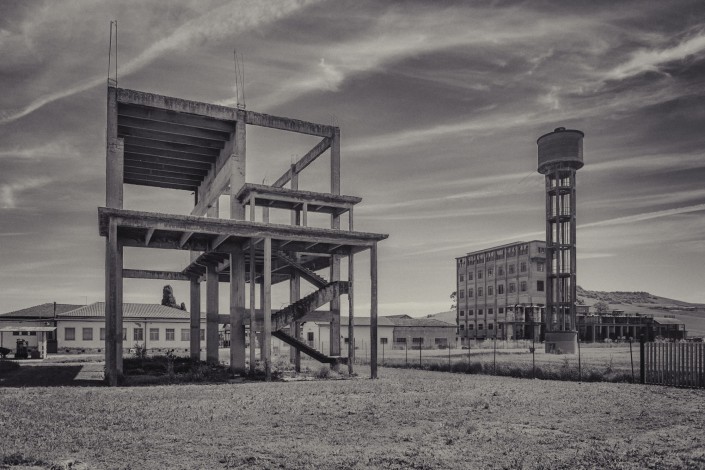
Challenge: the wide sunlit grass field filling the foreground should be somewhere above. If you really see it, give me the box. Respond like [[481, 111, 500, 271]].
[[0, 366, 705, 469]]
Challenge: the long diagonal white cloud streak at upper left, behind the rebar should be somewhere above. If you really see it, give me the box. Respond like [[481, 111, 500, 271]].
[[0, 0, 316, 124]]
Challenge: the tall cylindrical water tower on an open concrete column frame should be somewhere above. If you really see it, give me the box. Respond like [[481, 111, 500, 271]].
[[536, 127, 584, 354]]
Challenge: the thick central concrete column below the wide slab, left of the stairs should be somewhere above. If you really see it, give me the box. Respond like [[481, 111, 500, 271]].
[[230, 246, 245, 374]]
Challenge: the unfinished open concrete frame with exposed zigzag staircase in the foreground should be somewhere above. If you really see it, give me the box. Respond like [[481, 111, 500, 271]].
[[98, 83, 388, 385]]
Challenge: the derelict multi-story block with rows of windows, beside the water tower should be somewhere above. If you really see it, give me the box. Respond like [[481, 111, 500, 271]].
[[456, 240, 546, 345]]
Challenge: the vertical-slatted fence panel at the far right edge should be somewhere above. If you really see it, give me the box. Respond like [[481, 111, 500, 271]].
[[641, 343, 705, 388]]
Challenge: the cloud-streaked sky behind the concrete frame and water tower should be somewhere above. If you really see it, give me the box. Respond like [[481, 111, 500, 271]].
[[0, 0, 705, 316]]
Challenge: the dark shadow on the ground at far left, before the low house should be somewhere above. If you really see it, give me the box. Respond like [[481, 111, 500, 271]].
[[0, 364, 103, 387]]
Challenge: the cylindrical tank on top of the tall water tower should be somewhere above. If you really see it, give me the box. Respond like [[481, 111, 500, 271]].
[[536, 127, 585, 175]]
